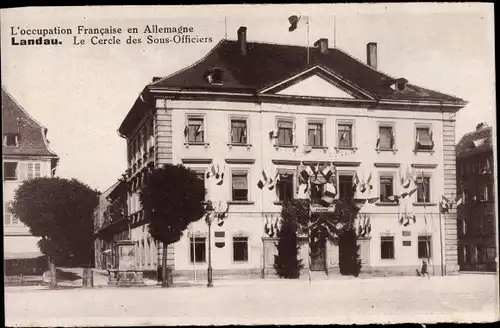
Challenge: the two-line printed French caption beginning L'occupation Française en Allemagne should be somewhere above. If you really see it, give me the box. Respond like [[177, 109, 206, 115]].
[[10, 24, 213, 46]]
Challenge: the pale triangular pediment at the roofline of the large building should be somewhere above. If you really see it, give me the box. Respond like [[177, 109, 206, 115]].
[[276, 75, 356, 99]]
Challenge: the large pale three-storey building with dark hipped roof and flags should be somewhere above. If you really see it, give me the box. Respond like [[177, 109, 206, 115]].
[[94, 27, 466, 276]]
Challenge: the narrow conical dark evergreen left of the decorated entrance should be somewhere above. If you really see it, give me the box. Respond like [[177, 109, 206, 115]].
[[274, 203, 304, 279]]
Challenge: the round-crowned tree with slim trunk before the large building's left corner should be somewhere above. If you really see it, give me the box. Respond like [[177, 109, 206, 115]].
[[139, 165, 206, 287]]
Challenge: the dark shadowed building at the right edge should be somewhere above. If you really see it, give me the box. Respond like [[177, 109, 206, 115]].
[[456, 123, 498, 272]]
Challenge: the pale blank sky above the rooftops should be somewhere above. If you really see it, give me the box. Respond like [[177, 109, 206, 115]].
[[1, 3, 496, 191]]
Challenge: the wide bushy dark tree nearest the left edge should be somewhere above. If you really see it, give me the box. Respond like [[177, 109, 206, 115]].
[[10, 177, 99, 287]]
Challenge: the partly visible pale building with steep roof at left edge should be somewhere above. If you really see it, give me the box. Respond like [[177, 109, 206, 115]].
[[2, 87, 59, 274]]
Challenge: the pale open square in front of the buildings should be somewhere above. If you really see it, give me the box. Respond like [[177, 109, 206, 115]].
[[5, 275, 498, 326]]
